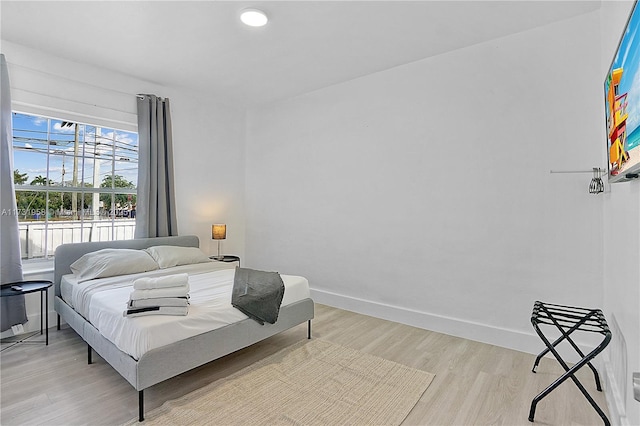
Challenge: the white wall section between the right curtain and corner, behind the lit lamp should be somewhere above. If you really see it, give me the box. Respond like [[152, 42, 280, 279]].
[[170, 87, 245, 257]]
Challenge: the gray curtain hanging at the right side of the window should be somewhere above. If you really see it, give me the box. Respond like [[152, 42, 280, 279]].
[[135, 95, 178, 238]]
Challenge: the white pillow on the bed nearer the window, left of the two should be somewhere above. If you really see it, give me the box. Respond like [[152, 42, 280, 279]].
[[70, 249, 158, 282]]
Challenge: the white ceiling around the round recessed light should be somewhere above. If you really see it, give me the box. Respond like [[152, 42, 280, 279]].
[[0, 0, 600, 106]]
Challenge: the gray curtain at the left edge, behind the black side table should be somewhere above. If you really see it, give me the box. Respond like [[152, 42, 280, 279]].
[[0, 54, 27, 331]]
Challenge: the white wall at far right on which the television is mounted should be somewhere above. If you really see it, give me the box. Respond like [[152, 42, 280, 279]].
[[601, 1, 640, 425]]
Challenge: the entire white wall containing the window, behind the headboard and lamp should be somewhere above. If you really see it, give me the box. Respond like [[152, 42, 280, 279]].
[[0, 41, 245, 337]]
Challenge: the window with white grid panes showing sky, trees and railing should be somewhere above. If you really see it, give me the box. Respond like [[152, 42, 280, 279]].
[[13, 112, 138, 259]]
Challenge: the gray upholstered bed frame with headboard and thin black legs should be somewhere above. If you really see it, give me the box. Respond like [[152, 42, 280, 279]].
[[54, 236, 314, 421]]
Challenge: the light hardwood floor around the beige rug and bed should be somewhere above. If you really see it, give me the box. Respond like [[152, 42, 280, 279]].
[[0, 305, 606, 426]]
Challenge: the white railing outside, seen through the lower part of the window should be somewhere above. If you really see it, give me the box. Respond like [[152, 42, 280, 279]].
[[18, 219, 136, 259]]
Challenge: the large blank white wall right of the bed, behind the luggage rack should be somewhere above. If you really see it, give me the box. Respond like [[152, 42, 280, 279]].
[[246, 13, 603, 352]]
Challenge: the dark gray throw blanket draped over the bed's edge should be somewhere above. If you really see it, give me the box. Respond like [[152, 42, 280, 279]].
[[231, 268, 284, 325]]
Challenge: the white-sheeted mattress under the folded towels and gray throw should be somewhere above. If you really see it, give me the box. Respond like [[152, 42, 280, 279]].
[[61, 262, 310, 359]]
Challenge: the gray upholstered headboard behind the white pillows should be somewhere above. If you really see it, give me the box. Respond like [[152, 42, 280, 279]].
[[53, 235, 200, 296]]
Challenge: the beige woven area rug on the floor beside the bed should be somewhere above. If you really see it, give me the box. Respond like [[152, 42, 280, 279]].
[[127, 339, 434, 426]]
